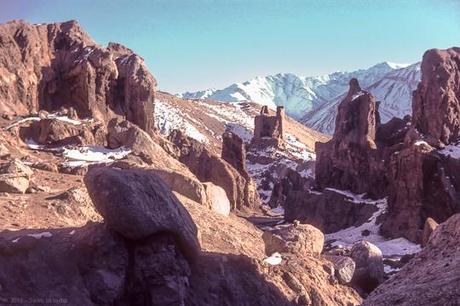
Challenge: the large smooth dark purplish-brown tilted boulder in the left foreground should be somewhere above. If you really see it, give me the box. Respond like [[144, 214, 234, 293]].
[[85, 168, 200, 257]]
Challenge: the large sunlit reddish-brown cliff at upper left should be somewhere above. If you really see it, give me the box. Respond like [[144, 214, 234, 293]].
[[0, 21, 156, 133]]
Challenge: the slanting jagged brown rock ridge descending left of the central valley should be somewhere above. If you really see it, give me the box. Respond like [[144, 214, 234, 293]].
[[169, 130, 259, 209]]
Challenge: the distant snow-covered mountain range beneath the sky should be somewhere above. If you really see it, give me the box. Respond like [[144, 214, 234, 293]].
[[179, 62, 420, 133]]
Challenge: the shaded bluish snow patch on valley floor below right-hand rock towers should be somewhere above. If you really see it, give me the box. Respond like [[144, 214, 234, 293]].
[[325, 189, 421, 256]]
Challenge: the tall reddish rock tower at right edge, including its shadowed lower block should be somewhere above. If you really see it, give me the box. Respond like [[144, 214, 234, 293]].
[[382, 48, 460, 242]]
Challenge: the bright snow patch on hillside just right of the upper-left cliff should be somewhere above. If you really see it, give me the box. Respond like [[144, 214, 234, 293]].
[[154, 100, 208, 143]]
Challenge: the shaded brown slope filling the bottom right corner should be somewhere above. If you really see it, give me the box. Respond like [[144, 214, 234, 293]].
[[364, 214, 460, 306]]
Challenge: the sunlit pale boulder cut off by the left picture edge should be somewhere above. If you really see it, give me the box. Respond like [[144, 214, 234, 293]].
[[0, 160, 33, 193]]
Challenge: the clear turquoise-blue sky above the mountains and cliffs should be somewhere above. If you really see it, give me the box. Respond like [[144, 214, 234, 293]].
[[0, 0, 460, 92]]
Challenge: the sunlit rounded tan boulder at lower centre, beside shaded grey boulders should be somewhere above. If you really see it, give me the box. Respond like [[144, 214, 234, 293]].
[[263, 224, 324, 257]]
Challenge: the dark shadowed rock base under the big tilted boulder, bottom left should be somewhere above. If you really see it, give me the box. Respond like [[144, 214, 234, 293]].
[[0, 223, 190, 306]]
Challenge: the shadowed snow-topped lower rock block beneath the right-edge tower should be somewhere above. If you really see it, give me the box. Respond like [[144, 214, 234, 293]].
[[381, 140, 460, 243]]
